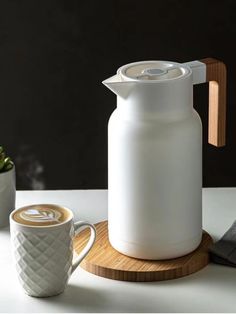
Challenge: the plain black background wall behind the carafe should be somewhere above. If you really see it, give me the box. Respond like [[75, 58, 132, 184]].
[[0, 0, 236, 189]]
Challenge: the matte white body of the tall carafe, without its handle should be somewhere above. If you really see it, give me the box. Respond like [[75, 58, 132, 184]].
[[106, 62, 202, 259]]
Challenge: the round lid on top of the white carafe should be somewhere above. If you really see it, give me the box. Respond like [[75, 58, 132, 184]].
[[117, 61, 191, 81]]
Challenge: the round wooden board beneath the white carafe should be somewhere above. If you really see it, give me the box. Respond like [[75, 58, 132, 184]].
[[74, 221, 213, 281]]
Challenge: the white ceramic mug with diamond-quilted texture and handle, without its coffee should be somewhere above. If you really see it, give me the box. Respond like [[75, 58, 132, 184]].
[[10, 204, 96, 297]]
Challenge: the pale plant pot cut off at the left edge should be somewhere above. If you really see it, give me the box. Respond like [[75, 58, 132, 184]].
[[0, 166, 16, 228]]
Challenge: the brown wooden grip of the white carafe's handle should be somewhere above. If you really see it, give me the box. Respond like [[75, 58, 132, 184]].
[[199, 58, 226, 147]]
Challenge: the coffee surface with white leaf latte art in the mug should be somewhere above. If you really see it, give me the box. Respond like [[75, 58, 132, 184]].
[[13, 204, 70, 226]]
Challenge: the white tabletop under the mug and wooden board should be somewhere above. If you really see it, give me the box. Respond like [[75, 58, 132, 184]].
[[0, 188, 236, 313]]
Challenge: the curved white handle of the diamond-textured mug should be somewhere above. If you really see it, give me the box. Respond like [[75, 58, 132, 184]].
[[71, 221, 96, 273]]
